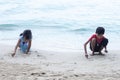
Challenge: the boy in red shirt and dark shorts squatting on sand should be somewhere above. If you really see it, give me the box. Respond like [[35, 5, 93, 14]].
[[84, 27, 108, 58]]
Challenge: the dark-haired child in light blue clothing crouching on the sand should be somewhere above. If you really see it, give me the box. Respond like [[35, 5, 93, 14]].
[[12, 30, 32, 57]]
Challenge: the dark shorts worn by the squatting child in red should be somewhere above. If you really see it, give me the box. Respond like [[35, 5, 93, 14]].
[[90, 38, 108, 52]]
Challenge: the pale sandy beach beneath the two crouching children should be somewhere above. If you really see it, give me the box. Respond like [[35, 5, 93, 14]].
[[0, 44, 120, 80]]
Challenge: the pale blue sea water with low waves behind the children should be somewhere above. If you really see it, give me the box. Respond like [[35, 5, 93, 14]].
[[0, 0, 120, 51]]
